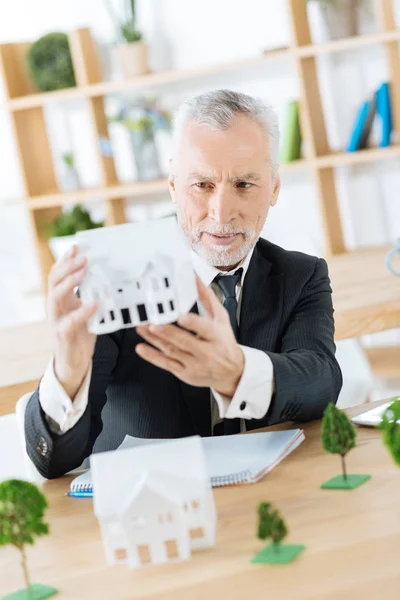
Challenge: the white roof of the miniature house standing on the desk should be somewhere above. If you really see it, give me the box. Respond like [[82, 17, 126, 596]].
[[90, 436, 210, 519]]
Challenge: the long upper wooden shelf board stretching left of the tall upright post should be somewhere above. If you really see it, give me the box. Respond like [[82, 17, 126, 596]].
[[7, 48, 292, 111]]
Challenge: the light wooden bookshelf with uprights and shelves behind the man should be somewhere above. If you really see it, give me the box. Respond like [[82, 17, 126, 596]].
[[0, 0, 400, 284]]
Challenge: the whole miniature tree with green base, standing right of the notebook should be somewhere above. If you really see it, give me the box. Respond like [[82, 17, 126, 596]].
[[321, 403, 370, 489]]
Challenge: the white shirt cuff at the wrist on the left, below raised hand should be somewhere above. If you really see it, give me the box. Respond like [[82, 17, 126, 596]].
[[39, 360, 92, 435]]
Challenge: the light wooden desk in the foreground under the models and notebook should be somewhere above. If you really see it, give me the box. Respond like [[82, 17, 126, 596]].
[[0, 407, 400, 600]]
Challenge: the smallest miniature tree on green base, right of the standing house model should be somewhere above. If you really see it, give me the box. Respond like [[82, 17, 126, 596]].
[[252, 502, 305, 564]]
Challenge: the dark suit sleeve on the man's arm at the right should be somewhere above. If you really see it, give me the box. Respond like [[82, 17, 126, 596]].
[[247, 259, 342, 429]]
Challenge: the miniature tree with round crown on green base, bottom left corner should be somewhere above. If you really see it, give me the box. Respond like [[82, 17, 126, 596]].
[[0, 479, 57, 600]]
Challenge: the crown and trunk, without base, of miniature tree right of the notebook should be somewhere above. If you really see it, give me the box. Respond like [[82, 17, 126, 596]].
[[322, 403, 356, 481]]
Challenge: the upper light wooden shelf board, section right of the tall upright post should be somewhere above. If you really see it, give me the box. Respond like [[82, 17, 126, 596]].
[[292, 30, 400, 58]]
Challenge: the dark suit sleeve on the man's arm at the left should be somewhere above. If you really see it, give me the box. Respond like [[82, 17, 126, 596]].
[[25, 332, 122, 479]]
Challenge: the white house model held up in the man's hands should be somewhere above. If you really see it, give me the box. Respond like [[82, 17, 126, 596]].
[[76, 217, 197, 334]]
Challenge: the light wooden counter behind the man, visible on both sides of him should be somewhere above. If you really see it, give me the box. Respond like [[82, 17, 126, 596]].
[[0, 247, 400, 388]]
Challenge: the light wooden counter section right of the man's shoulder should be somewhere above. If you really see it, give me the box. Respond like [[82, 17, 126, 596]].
[[328, 246, 400, 340]]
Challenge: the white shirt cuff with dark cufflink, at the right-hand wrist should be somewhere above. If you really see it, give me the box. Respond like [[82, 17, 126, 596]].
[[212, 346, 274, 419]]
